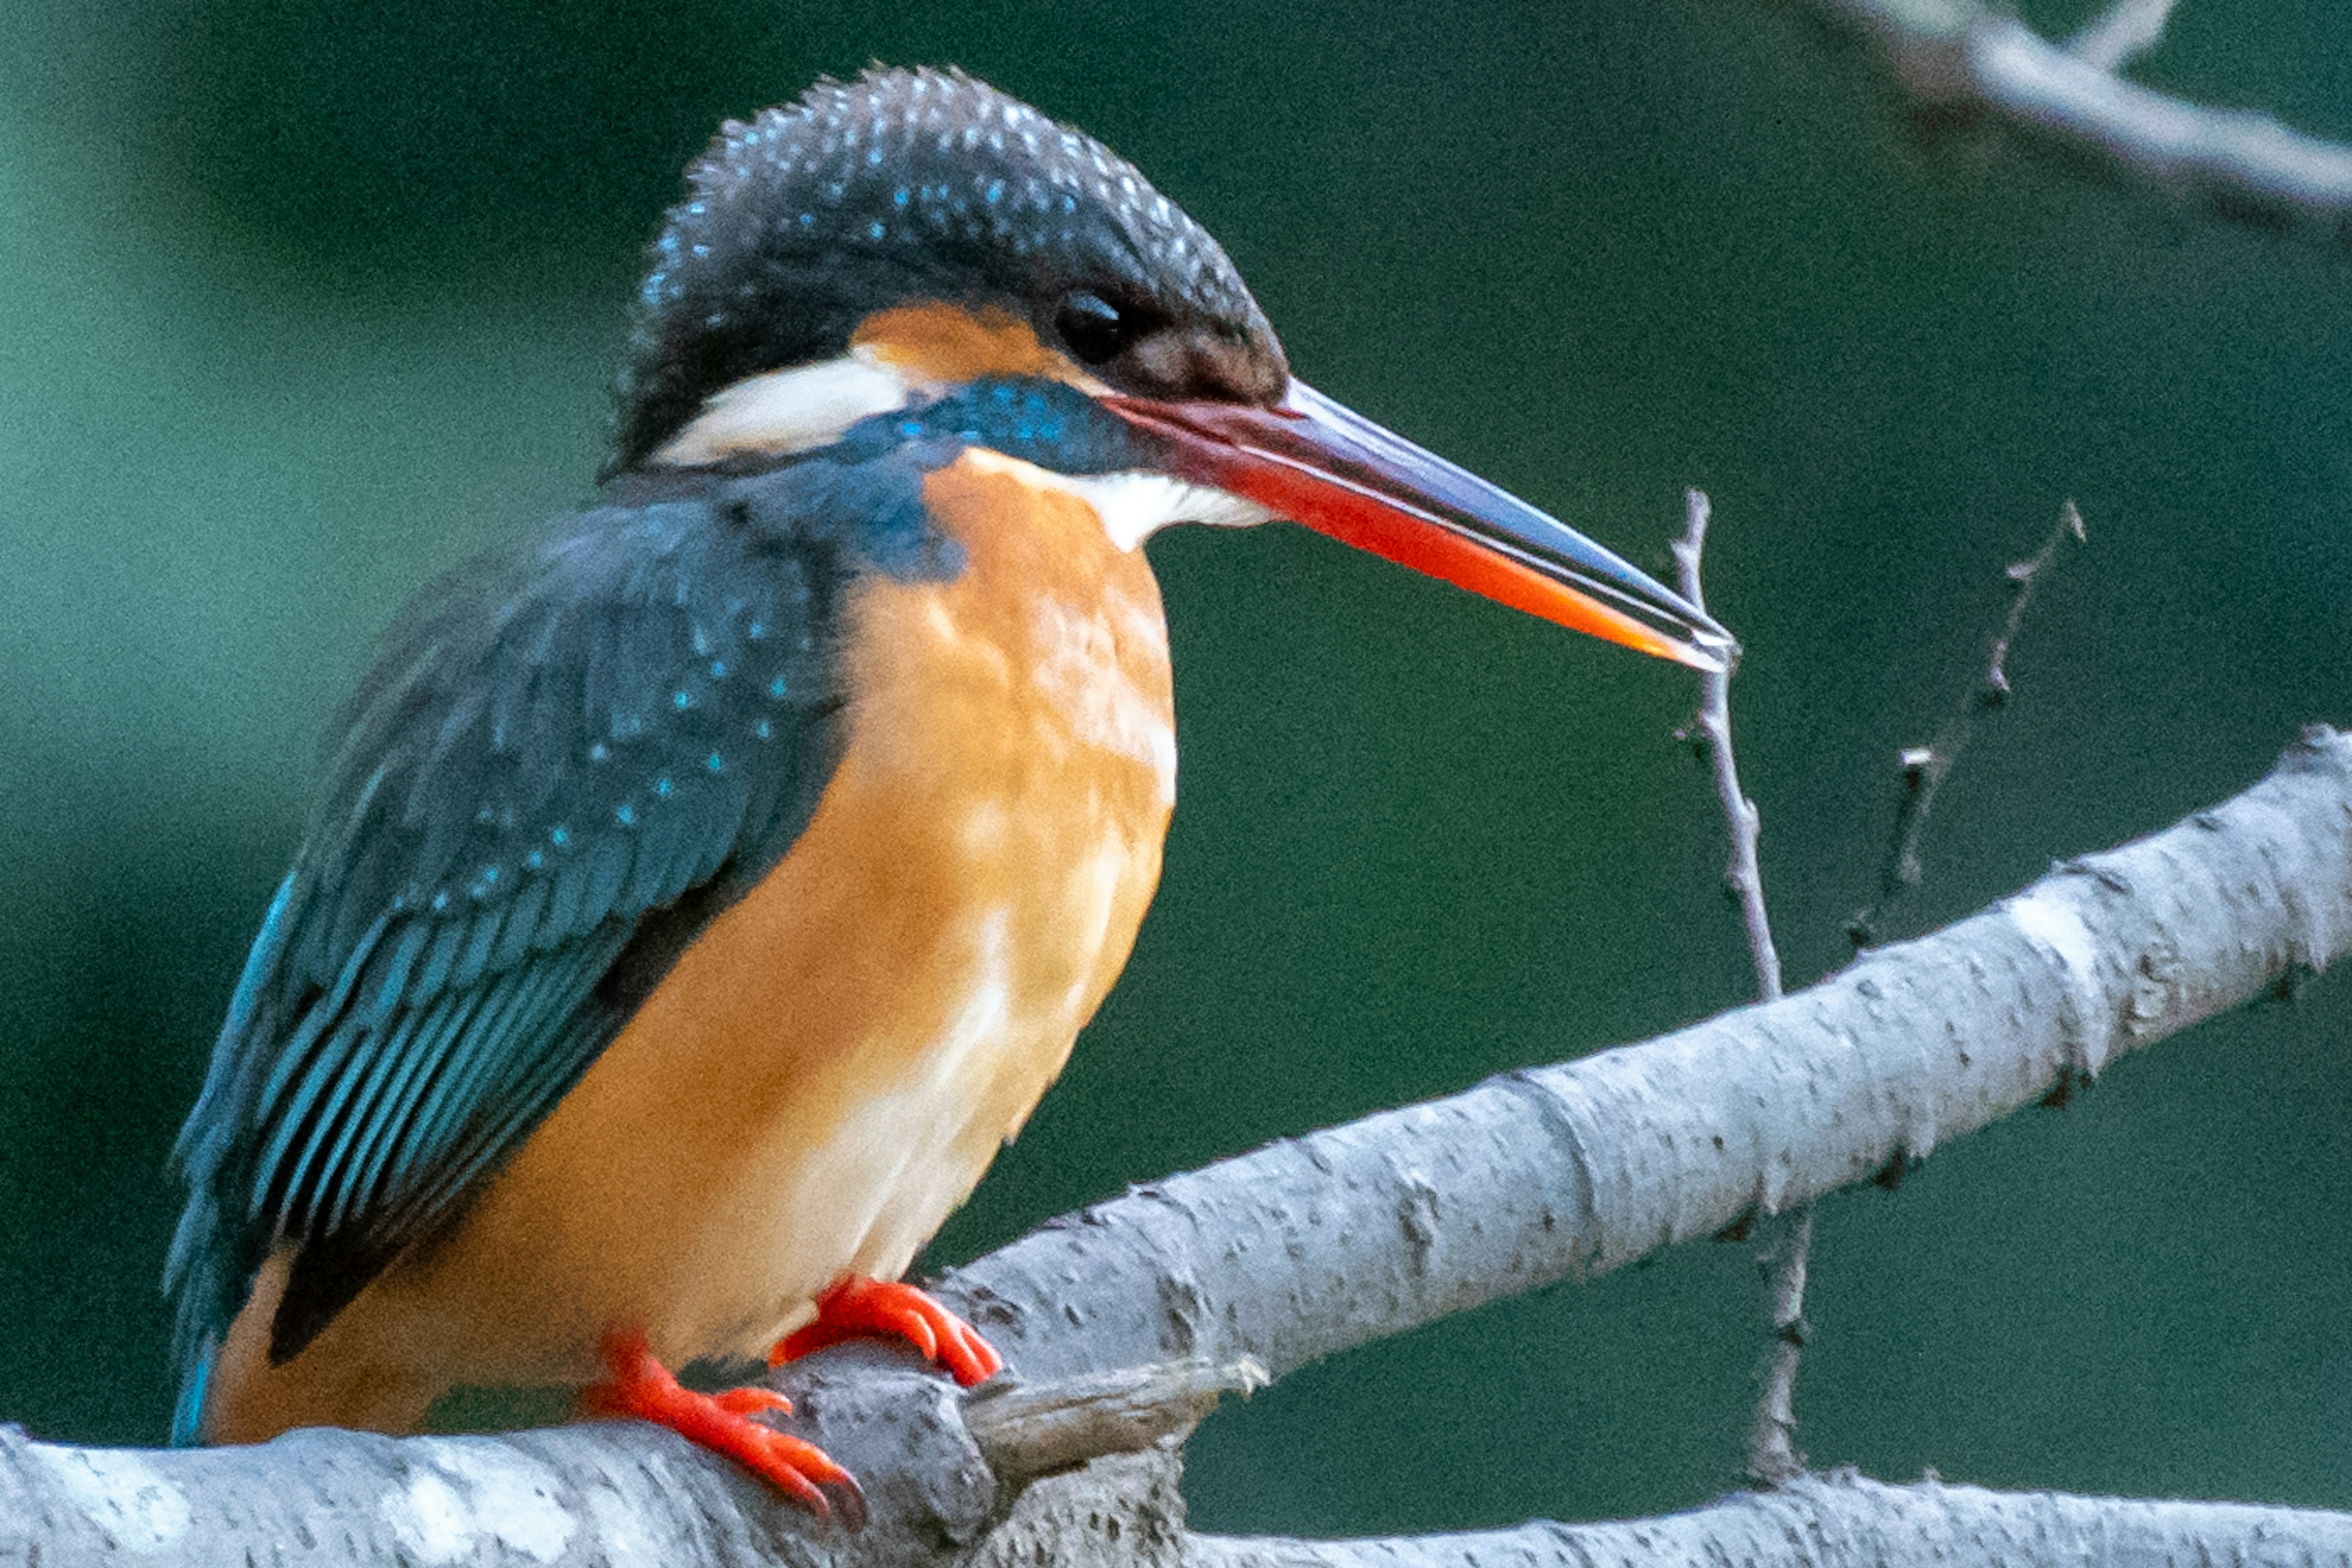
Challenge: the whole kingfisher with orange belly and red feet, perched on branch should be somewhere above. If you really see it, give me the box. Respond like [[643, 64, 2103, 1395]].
[[165, 68, 1736, 1517]]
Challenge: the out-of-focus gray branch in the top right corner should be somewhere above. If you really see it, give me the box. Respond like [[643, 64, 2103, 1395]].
[[1814, 0, 2352, 244]]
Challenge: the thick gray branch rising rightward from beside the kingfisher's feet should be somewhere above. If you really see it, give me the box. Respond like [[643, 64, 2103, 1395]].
[[941, 729, 2352, 1378]]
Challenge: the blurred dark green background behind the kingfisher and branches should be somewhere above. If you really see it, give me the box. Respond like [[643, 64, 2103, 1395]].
[[0, 0, 2352, 1532]]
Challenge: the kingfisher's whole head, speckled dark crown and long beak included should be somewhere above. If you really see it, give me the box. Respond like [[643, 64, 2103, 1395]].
[[614, 70, 1738, 668]]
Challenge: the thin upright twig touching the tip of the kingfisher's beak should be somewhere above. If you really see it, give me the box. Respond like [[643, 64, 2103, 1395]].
[[1675, 489, 1814, 1486]]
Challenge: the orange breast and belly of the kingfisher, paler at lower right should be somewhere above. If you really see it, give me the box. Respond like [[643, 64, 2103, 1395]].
[[205, 454, 1176, 1441]]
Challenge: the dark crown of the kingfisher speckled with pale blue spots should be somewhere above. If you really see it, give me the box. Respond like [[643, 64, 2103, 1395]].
[[614, 70, 1289, 468]]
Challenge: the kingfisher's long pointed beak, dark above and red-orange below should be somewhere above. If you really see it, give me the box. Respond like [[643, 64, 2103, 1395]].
[[1103, 381, 1741, 670]]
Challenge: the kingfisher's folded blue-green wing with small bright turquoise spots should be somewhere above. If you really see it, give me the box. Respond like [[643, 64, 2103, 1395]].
[[167, 444, 955, 1436]]
